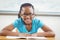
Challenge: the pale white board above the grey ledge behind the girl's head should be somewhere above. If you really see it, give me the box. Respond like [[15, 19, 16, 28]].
[[0, 0, 60, 15]]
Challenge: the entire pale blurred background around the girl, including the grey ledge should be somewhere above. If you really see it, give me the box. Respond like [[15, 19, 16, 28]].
[[0, 0, 60, 40]]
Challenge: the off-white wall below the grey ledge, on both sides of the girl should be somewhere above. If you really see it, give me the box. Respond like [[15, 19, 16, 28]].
[[0, 15, 60, 40]]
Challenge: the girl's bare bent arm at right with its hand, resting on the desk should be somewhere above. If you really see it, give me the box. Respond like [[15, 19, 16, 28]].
[[32, 25, 55, 37]]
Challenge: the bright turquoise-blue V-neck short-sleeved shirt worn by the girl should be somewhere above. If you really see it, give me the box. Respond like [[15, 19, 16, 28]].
[[13, 18, 44, 34]]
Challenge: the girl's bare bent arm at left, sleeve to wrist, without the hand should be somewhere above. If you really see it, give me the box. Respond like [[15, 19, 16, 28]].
[[0, 24, 19, 36]]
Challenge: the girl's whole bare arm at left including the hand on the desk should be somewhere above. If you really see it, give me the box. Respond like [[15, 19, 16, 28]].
[[0, 24, 30, 36]]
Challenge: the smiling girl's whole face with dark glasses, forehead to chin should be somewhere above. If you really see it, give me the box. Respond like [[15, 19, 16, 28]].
[[20, 6, 33, 24]]
